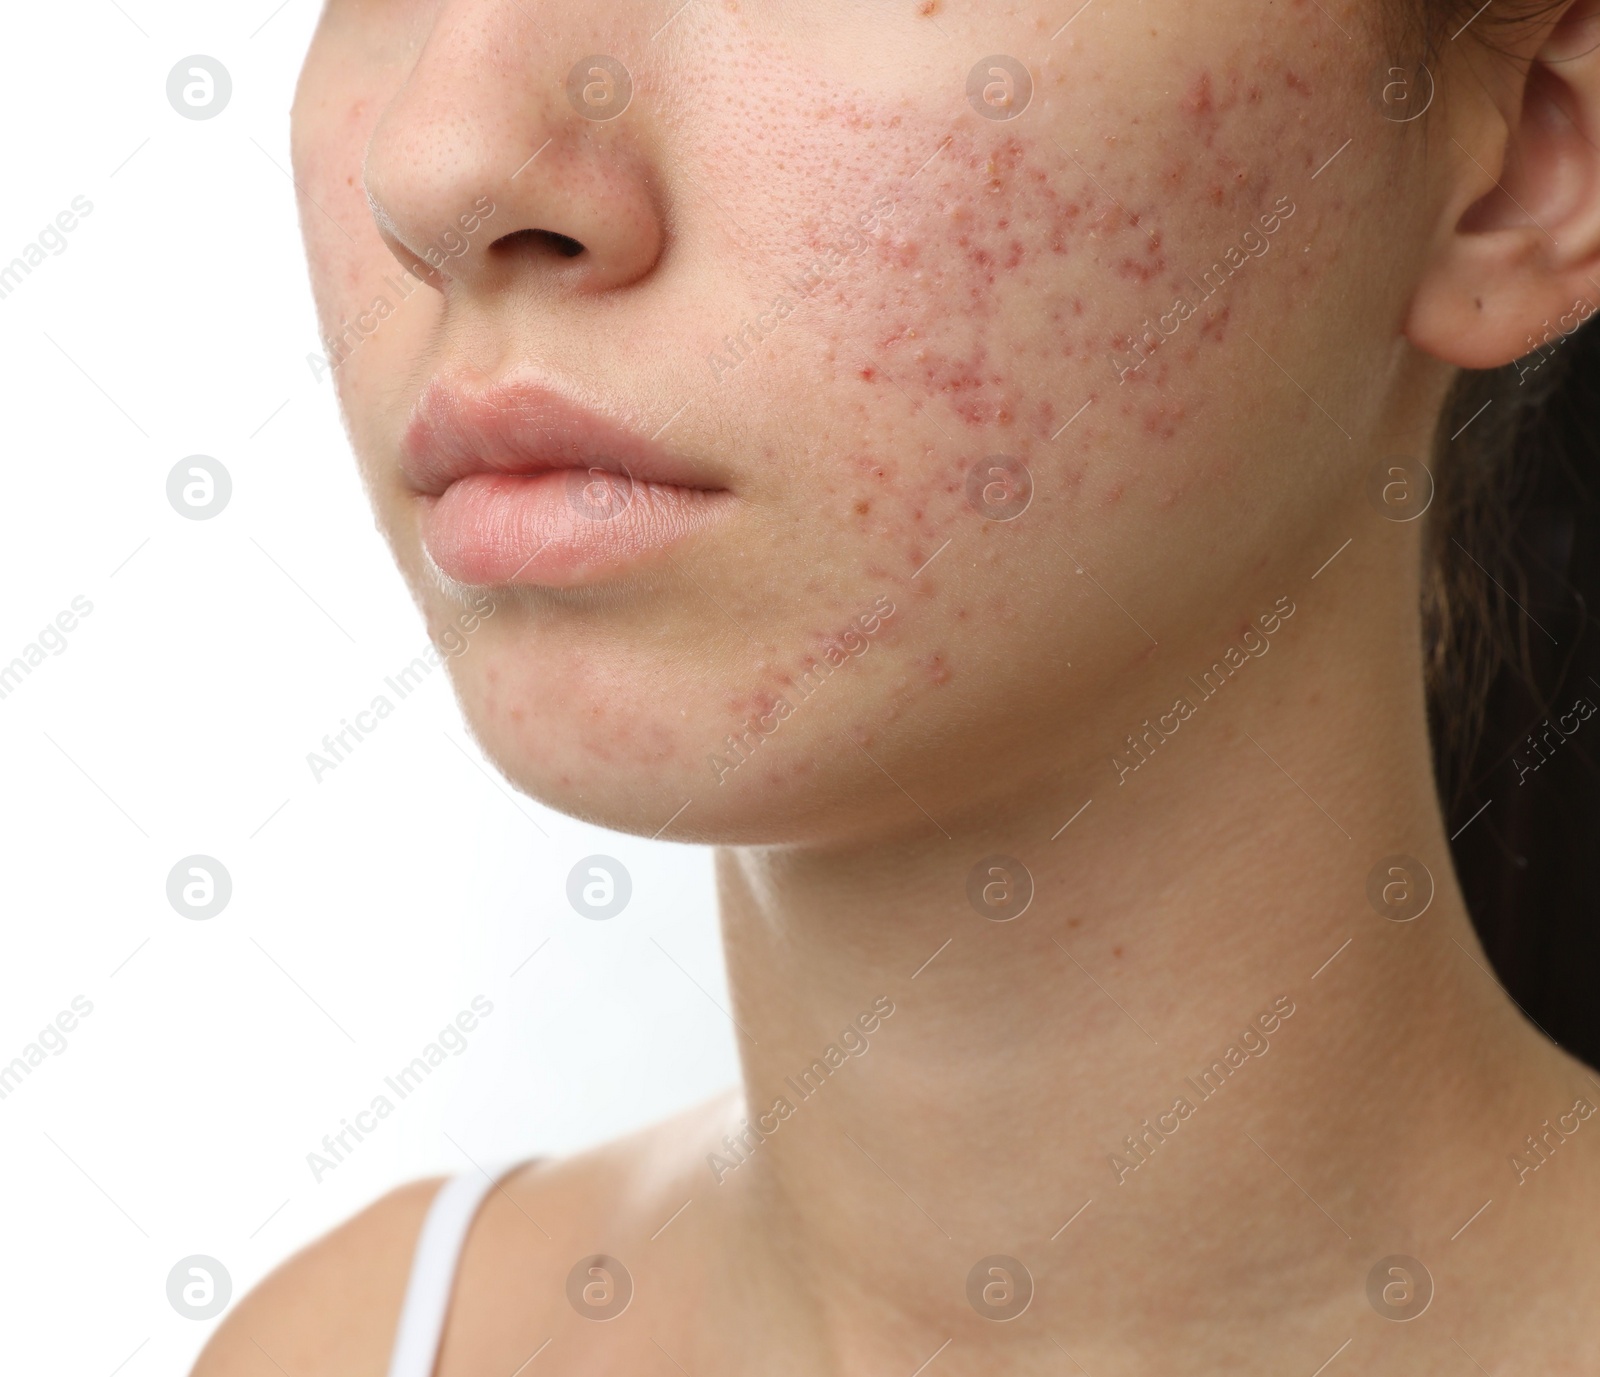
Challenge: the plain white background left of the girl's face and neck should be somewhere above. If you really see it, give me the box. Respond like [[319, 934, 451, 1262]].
[[0, 0, 736, 1377]]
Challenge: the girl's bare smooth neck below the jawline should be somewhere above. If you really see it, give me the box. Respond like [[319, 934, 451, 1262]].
[[697, 524, 1581, 1371]]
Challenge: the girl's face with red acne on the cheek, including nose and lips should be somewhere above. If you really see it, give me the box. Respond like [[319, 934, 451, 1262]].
[[294, 0, 1435, 841]]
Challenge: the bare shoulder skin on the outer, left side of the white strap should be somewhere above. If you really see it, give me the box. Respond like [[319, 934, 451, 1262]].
[[190, 1179, 442, 1377]]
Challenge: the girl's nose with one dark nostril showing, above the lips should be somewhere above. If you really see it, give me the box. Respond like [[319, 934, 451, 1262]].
[[363, 0, 664, 296]]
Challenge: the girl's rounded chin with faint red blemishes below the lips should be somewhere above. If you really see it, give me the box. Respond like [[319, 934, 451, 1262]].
[[430, 594, 960, 846]]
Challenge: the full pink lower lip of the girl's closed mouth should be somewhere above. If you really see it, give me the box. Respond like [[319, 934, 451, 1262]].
[[422, 469, 733, 587]]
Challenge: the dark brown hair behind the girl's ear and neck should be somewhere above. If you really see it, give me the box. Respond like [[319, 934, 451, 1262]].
[[1400, 0, 1600, 1065]]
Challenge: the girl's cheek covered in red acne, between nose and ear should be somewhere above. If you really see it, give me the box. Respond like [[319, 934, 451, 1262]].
[[668, 21, 1381, 764]]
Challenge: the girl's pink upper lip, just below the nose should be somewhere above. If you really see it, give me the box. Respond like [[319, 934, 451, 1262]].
[[400, 376, 726, 496]]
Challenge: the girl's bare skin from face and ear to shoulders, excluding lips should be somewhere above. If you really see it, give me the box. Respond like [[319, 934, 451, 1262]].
[[198, 0, 1600, 1377]]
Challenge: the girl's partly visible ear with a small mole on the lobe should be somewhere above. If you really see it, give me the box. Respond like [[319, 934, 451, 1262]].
[[1405, 0, 1600, 368]]
